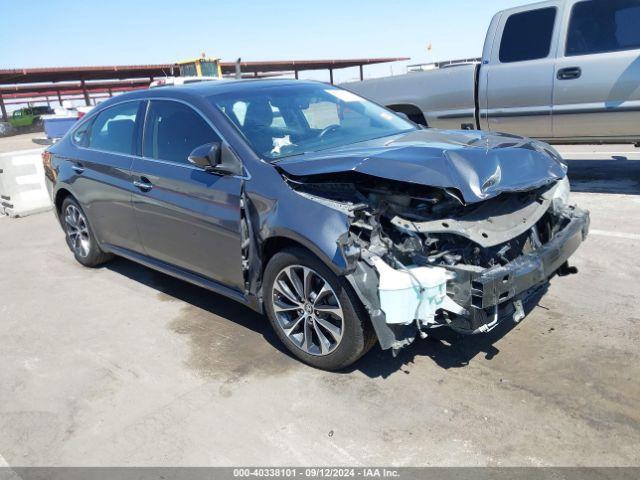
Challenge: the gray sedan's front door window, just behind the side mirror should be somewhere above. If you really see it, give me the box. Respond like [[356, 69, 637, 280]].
[[143, 100, 220, 163]]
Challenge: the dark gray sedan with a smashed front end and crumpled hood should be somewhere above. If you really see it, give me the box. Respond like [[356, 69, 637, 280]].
[[43, 80, 589, 370]]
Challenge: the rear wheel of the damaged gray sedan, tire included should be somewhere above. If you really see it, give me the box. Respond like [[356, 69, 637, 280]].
[[60, 197, 112, 267]]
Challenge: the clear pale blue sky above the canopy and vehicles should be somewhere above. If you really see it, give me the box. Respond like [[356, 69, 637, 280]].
[[0, 0, 531, 81]]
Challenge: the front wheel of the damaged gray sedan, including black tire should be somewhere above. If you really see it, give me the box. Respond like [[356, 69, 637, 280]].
[[264, 248, 375, 371]]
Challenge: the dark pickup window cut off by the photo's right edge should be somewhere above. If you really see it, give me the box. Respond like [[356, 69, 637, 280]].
[[566, 0, 640, 57]]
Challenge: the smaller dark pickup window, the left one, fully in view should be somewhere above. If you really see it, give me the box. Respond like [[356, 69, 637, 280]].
[[500, 7, 556, 63]]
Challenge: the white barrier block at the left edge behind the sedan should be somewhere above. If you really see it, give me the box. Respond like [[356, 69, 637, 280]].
[[0, 148, 52, 217]]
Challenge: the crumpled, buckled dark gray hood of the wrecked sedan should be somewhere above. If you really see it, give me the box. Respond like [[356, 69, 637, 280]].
[[277, 129, 567, 203]]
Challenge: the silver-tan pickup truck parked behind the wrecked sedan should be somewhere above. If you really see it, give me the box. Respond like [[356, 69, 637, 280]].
[[342, 0, 640, 143]]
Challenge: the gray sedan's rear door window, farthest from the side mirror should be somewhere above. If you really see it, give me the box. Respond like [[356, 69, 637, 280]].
[[88, 102, 140, 155]]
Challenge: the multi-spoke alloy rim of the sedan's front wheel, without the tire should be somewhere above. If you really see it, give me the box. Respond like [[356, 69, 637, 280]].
[[271, 265, 344, 356]]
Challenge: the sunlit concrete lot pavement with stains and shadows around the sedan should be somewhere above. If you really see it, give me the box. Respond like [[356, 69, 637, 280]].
[[0, 142, 640, 466]]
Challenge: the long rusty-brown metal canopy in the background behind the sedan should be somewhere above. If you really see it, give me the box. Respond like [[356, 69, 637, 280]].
[[0, 57, 409, 121]]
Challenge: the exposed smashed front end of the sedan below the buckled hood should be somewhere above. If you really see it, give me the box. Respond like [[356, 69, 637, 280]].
[[285, 172, 589, 350]]
